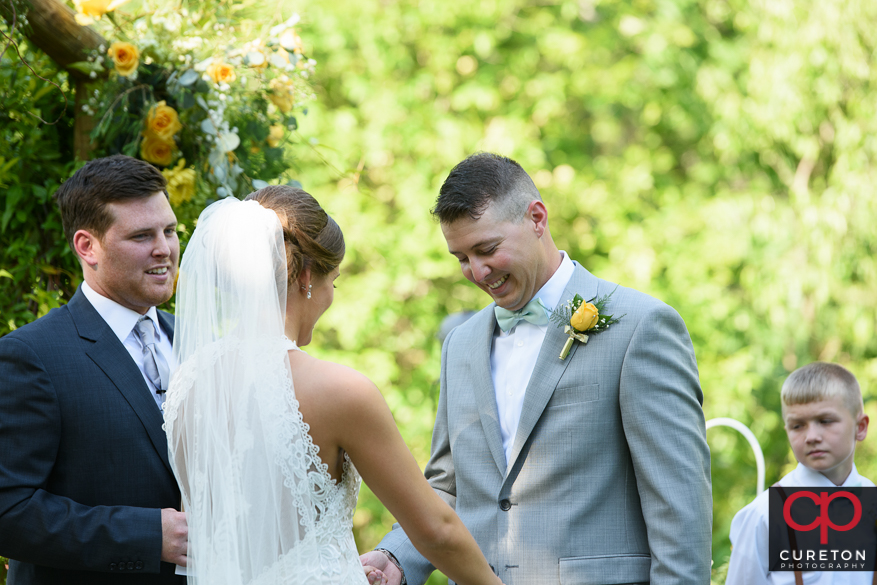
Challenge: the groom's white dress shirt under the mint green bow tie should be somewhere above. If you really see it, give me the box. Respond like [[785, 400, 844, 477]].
[[490, 250, 575, 463]]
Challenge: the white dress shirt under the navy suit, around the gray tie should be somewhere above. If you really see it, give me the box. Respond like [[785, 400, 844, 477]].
[[82, 282, 177, 408]]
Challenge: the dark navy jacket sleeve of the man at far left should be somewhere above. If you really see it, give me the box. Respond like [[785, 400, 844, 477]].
[[0, 336, 162, 573]]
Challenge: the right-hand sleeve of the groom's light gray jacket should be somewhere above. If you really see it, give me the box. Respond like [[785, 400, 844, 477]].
[[619, 303, 712, 585]]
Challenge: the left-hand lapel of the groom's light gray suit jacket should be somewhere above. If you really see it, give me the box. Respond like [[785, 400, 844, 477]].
[[470, 303, 506, 475]]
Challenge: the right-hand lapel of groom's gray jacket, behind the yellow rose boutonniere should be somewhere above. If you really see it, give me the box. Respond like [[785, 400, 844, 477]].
[[508, 264, 598, 469]]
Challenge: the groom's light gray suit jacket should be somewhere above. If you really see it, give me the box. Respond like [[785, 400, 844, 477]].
[[379, 265, 712, 585]]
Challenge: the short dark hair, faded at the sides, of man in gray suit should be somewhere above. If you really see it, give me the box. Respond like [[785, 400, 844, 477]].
[[432, 152, 542, 224]]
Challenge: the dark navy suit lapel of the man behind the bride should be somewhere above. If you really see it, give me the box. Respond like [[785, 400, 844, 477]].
[[67, 290, 173, 471]]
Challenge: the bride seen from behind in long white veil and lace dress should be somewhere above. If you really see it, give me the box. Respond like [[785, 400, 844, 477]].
[[165, 186, 500, 585]]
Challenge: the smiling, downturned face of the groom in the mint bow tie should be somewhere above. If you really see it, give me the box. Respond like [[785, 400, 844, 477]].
[[441, 201, 551, 311]]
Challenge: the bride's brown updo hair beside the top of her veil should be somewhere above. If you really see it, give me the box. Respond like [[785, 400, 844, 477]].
[[246, 185, 344, 287]]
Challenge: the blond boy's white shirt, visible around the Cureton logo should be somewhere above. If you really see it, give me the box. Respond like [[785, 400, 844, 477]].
[[725, 463, 874, 585]]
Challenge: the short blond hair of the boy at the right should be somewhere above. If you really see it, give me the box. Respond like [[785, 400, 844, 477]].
[[781, 362, 865, 418]]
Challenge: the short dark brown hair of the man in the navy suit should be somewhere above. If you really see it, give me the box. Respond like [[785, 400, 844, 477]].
[[55, 154, 167, 252]]
